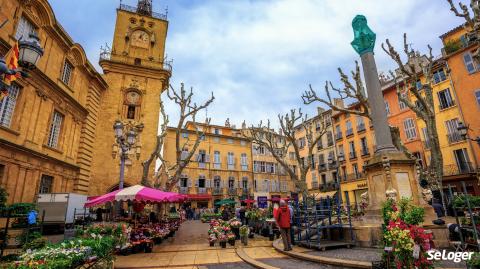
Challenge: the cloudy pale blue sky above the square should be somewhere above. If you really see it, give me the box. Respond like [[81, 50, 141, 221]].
[[50, 0, 462, 126]]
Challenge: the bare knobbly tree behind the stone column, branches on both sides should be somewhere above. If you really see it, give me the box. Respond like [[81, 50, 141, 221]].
[[302, 34, 444, 207]]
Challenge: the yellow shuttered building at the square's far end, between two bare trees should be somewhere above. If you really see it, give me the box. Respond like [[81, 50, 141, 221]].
[[163, 122, 293, 208]]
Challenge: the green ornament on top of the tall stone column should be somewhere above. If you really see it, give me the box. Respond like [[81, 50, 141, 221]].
[[350, 15, 377, 56]]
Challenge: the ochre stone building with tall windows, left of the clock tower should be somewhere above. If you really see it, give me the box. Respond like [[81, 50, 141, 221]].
[[0, 0, 107, 203]]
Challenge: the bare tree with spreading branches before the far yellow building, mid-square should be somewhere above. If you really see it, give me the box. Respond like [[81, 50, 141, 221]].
[[243, 109, 327, 197]]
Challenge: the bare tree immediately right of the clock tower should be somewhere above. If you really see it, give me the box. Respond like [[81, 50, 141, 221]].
[[142, 83, 215, 191]]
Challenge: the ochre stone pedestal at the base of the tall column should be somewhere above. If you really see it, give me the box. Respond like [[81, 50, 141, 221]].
[[363, 151, 436, 225]]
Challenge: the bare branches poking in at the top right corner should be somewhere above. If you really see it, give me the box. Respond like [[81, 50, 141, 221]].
[[447, 0, 480, 62]]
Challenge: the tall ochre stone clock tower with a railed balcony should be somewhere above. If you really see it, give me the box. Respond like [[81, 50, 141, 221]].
[[87, 0, 172, 195]]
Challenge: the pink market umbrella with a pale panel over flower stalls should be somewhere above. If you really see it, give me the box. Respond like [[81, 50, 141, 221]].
[[85, 185, 186, 207]]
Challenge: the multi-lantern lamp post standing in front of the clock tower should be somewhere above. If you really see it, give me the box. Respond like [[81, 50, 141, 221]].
[[113, 120, 137, 190]]
